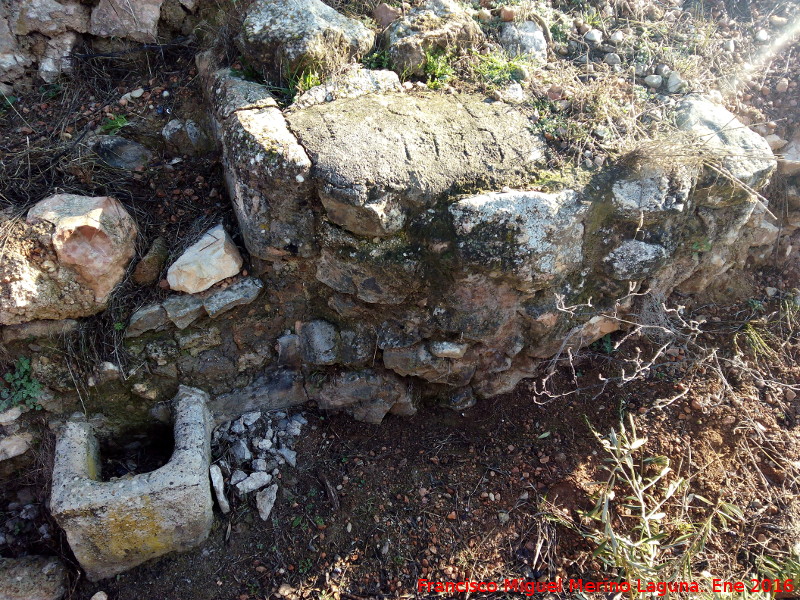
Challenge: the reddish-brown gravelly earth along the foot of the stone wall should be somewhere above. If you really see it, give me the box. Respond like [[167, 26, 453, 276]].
[[17, 286, 800, 599]]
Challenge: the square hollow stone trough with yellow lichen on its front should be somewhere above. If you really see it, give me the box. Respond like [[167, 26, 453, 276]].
[[50, 386, 213, 581]]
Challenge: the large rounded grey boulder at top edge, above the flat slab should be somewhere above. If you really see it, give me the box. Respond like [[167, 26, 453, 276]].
[[238, 0, 375, 79]]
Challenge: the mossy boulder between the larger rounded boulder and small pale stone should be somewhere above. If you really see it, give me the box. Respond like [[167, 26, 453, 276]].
[[384, 0, 484, 75]]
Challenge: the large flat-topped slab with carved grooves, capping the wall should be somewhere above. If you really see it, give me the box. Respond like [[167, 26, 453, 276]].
[[287, 94, 544, 237]]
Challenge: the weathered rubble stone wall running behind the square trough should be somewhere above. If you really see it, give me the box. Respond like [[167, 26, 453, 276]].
[[0, 0, 800, 482]]
